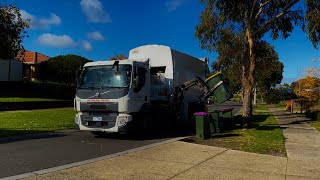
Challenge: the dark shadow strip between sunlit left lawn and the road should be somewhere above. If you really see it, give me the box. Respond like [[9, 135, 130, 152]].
[[0, 129, 67, 144]]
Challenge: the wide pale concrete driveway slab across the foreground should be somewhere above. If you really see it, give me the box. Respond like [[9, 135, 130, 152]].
[[11, 141, 320, 180]]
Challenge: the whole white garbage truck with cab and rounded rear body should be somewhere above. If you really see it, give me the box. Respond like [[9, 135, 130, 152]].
[[75, 45, 209, 132]]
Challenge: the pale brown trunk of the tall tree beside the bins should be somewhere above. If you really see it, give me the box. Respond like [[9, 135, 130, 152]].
[[242, 28, 255, 124]]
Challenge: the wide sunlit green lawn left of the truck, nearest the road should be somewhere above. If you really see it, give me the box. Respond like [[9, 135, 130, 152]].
[[0, 108, 75, 137]]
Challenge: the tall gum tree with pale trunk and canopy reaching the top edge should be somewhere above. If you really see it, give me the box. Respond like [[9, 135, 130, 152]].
[[195, 0, 320, 117]]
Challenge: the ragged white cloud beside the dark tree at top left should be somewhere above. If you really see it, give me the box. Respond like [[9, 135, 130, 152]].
[[20, 10, 61, 29]]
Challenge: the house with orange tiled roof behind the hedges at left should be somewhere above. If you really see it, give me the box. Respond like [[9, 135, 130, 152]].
[[16, 50, 50, 80]]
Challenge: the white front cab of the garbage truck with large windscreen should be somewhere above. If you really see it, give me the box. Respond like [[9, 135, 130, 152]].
[[74, 59, 150, 132]]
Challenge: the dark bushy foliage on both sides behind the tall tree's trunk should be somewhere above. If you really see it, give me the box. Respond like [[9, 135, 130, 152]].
[[212, 29, 284, 92]]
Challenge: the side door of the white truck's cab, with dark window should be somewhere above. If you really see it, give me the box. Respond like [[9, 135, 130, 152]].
[[132, 63, 150, 107]]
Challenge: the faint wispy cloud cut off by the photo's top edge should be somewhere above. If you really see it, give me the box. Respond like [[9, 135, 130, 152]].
[[80, 0, 112, 23]]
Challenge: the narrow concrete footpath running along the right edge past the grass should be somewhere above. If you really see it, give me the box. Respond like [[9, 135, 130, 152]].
[[270, 108, 320, 179]]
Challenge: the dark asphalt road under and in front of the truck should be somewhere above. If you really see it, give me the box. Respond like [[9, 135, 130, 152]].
[[0, 102, 241, 178]]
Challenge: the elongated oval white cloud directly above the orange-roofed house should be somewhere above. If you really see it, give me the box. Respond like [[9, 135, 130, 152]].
[[38, 33, 75, 48]]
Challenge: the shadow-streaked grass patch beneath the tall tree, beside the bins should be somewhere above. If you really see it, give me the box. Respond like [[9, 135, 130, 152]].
[[186, 106, 286, 156]]
